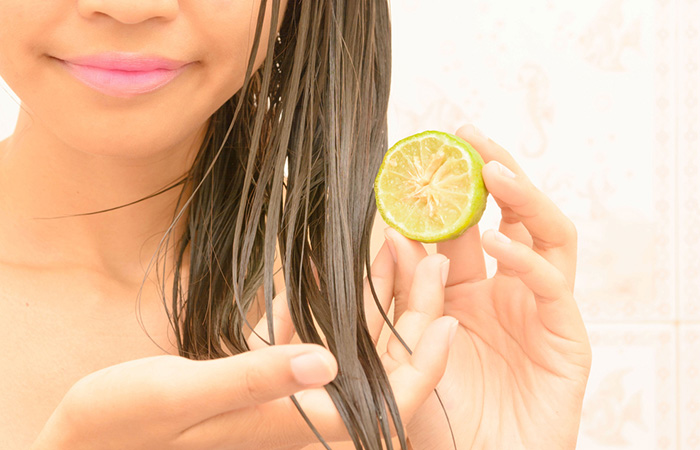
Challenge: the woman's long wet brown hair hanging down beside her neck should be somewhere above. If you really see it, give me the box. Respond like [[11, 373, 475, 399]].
[[157, 0, 406, 449]]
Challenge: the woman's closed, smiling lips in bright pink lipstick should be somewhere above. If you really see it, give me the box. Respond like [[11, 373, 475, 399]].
[[60, 53, 188, 97]]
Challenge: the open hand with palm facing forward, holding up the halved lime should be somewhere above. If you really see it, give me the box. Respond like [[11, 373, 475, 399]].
[[380, 126, 591, 450]]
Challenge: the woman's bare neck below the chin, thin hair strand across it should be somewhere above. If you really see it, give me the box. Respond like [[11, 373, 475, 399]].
[[0, 108, 204, 280]]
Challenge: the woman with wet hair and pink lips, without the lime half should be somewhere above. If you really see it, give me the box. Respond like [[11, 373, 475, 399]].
[[0, 0, 590, 450]]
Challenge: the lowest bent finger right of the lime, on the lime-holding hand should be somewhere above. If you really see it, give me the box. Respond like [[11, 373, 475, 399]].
[[483, 230, 586, 342]]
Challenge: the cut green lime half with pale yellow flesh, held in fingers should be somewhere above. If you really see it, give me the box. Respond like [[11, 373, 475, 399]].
[[374, 131, 488, 242]]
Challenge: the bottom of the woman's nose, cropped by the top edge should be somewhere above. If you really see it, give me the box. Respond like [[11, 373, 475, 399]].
[[78, 0, 180, 25]]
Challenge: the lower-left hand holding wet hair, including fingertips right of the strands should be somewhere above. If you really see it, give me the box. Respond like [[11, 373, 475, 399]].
[[32, 248, 457, 450]]
